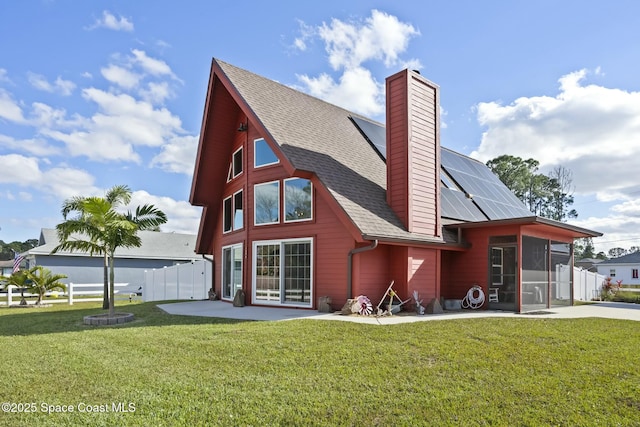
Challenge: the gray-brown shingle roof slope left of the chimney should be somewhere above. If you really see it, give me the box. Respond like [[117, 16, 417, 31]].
[[215, 60, 438, 242]]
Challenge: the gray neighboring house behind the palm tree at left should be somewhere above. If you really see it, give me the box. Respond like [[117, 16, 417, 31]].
[[22, 228, 201, 292]]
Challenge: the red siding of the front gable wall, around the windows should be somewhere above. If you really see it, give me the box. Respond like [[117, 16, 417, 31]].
[[213, 116, 355, 308]]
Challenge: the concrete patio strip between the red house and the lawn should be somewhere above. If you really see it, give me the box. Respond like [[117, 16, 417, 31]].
[[158, 301, 640, 325]]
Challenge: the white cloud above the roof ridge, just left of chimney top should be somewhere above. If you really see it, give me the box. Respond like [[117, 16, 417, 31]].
[[294, 9, 420, 116]]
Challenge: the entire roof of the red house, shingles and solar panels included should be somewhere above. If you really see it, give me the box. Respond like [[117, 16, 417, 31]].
[[191, 59, 600, 249]]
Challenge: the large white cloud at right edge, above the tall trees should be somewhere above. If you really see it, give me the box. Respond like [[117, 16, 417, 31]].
[[471, 70, 640, 200]]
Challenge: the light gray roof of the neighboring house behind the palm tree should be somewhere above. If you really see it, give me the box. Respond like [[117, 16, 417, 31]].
[[26, 228, 199, 260]]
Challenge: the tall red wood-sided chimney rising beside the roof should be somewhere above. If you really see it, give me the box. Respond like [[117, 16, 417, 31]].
[[386, 70, 441, 237]]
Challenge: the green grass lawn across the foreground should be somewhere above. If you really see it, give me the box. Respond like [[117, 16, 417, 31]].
[[0, 303, 640, 426]]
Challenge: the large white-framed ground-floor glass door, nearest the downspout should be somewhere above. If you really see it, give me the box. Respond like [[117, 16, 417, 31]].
[[253, 238, 313, 307]]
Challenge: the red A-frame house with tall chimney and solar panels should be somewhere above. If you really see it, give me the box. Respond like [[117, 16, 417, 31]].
[[190, 59, 600, 311]]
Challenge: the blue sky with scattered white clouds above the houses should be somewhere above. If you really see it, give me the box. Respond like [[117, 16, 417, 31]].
[[0, 0, 640, 258]]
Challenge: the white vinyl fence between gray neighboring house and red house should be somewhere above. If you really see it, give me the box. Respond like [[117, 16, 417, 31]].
[[142, 260, 212, 301]]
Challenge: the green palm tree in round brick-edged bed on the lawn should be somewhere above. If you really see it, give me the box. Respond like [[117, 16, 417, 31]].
[[52, 185, 167, 316]]
